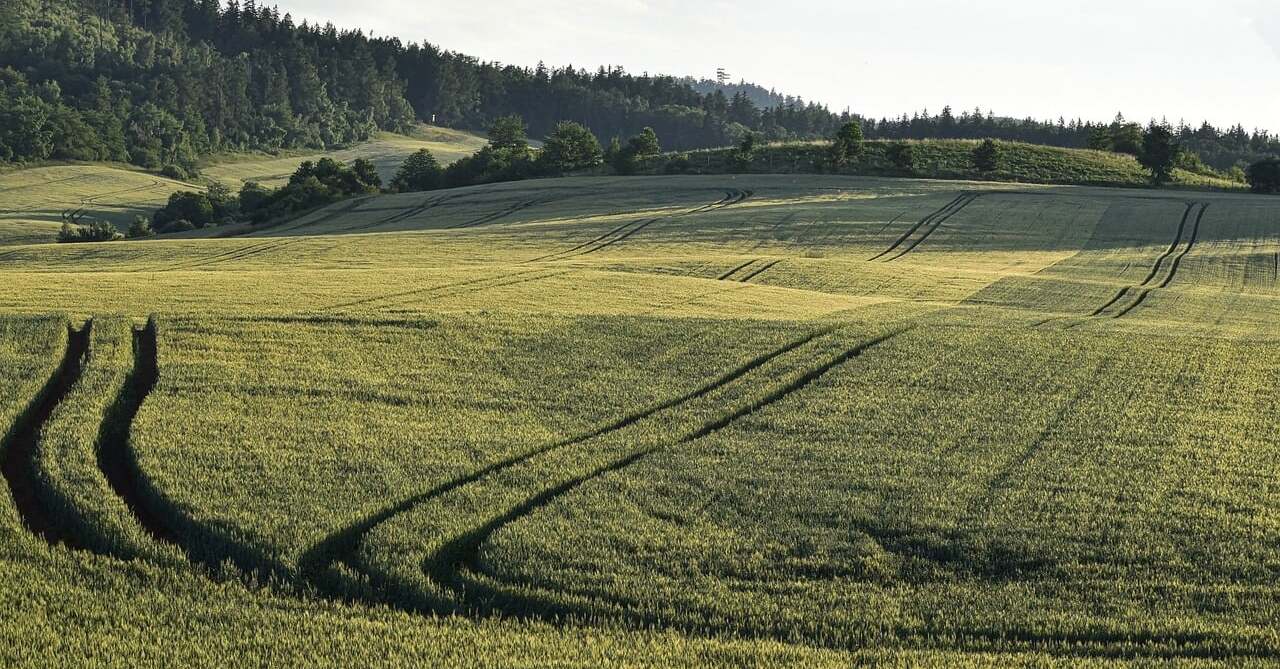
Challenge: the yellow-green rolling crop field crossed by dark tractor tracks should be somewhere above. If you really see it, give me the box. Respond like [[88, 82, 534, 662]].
[[0, 175, 1280, 666]]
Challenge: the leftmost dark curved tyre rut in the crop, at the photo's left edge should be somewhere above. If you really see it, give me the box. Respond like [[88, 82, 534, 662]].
[[0, 321, 93, 547]]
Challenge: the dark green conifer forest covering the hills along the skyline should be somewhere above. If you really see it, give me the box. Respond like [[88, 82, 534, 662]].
[[0, 0, 1280, 177]]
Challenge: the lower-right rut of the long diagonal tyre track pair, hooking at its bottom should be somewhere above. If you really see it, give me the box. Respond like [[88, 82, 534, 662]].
[[440, 330, 905, 617]]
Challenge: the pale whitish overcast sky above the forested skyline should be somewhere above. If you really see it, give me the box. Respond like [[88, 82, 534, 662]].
[[280, 0, 1280, 132]]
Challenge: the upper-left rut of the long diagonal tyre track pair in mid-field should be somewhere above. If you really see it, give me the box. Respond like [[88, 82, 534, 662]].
[[300, 327, 832, 603]]
